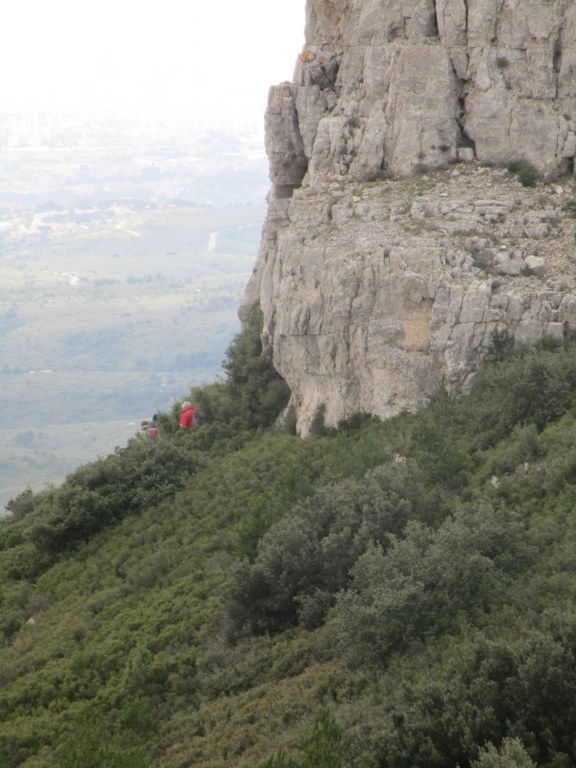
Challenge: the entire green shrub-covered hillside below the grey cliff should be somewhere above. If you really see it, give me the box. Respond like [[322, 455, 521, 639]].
[[0, 317, 576, 768]]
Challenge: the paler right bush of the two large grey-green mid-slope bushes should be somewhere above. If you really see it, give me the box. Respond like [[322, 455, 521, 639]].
[[336, 506, 532, 662]]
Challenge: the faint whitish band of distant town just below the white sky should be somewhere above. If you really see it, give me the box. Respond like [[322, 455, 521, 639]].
[[0, 113, 269, 224]]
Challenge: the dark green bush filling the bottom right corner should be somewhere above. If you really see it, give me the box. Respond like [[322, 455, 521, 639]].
[[372, 609, 576, 768]]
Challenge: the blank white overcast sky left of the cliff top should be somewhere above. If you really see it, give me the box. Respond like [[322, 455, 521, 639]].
[[0, 0, 305, 120]]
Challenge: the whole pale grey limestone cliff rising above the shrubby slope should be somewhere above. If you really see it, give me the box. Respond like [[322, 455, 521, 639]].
[[240, 0, 576, 434]]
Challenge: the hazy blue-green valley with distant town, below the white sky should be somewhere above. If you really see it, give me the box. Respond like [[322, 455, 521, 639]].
[[0, 114, 268, 514]]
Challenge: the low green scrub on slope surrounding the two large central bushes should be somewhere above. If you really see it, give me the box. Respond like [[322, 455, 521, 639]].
[[0, 344, 576, 768]]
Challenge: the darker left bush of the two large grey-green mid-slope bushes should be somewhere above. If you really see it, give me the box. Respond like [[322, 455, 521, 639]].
[[227, 463, 429, 637]]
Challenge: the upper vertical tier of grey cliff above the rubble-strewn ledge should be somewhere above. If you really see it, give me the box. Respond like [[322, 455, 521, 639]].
[[280, 0, 576, 180]]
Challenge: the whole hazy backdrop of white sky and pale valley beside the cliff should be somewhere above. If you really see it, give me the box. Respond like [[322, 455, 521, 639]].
[[0, 6, 304, 514]]
